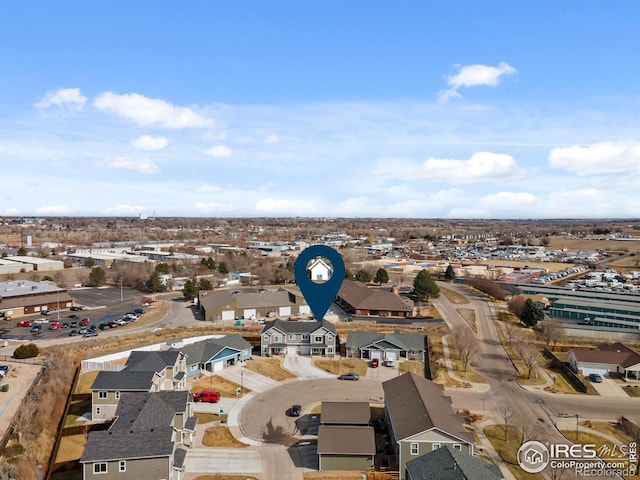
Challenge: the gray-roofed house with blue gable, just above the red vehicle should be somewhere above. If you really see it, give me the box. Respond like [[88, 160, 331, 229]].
[[173, 334, 252, 377]]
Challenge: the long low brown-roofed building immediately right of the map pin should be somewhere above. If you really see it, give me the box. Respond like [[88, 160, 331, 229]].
[[336, 280, 413, 317]]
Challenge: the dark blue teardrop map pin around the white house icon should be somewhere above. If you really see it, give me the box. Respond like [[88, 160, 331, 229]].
[[294, 245, 345, 322]]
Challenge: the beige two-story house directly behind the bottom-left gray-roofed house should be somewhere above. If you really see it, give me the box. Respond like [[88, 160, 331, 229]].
[[91, 350, 187, 420]]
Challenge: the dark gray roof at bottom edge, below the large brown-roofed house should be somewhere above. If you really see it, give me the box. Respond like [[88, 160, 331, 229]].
[[406, 445, 504, 480]]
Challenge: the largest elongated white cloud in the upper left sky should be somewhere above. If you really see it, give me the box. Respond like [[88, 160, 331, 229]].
[[93, 92, 214, 129]]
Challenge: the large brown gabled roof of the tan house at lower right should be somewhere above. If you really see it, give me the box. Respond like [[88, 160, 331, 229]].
[[382, 373, 473, 443]]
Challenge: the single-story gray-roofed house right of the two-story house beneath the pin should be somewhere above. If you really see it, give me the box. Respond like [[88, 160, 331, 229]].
[[346, 331, 425, 362]]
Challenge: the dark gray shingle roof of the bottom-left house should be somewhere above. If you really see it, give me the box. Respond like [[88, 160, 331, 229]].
[[80, 392, 190, 462]]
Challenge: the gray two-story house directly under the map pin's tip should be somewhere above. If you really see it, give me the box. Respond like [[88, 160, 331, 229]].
[[260, 319, 337, 356]]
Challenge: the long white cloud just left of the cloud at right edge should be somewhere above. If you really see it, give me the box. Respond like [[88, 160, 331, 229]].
[[418, 152, 522, 183]]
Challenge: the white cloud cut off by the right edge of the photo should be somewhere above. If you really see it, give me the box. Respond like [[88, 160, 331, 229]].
[[549, 140, 640, 176]]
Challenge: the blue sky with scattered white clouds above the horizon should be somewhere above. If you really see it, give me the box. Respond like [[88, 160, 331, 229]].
[[0, 0, 640, 218]]
